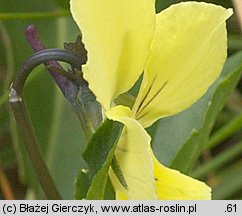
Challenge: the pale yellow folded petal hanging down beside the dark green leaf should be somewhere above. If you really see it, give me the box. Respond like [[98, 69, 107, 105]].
[[106, 106, 157, 200]]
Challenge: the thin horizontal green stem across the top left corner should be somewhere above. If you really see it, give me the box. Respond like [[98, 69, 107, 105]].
[[0, 11, 70, 20]]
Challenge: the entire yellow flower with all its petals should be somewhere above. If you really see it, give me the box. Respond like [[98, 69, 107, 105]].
[[71, 0, 232, 200]]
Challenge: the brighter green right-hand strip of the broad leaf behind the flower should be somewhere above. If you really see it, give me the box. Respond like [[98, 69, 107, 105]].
[[171, 52, 242, 172]]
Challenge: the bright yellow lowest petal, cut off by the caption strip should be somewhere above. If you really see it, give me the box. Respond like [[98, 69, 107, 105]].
[[153, 156, 211, 200]]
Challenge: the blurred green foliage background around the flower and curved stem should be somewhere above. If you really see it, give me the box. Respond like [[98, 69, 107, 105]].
[[0, 0, 242, 199]]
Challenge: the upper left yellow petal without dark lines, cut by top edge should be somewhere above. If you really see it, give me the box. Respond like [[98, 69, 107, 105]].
[[70, 0, 155, 110]]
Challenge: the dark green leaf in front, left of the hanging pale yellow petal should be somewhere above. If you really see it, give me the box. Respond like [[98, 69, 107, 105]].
[[76, 120, 122, 200]]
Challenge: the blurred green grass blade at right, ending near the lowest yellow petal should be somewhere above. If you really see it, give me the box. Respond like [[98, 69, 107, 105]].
[[192, 142, 242, 178]]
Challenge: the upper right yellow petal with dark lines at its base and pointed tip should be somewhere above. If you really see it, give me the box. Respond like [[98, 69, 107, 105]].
[[134, 2, 232, 127]]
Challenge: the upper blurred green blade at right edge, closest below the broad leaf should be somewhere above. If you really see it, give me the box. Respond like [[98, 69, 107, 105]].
[[205, 114, 242, 149]]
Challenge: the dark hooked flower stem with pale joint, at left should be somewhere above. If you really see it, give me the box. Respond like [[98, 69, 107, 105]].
[[9, 49, 81, 199]]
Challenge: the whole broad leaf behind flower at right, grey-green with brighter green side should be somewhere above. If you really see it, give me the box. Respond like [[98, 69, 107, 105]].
[[150, 52, 242, 173]]
